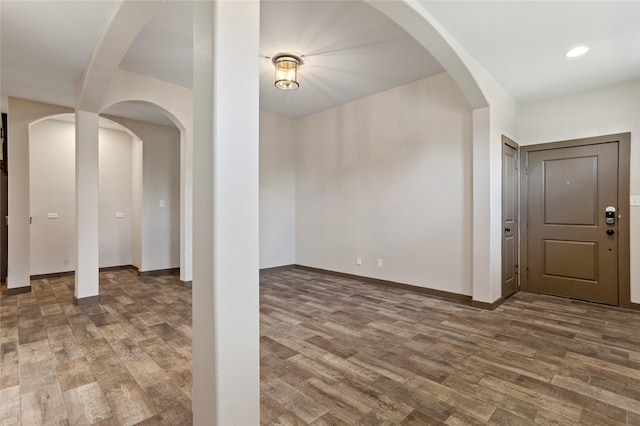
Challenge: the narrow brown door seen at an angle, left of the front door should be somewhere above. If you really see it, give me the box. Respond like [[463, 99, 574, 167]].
[[502, 136, 518, 298]]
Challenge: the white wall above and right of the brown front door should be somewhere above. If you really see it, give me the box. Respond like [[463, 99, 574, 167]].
[[517, 80, 640, 303]]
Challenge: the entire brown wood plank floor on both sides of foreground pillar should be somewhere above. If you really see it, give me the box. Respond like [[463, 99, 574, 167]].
[[0, 269, 640, 426]]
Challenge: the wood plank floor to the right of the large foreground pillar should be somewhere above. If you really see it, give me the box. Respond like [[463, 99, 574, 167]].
[[260, 269, 640, 425]]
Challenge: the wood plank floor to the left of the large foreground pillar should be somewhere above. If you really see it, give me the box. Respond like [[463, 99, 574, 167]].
[[0, 270, 192, 426]]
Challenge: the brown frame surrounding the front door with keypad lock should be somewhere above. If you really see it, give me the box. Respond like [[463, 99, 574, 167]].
[[519, 133, 640, 310]]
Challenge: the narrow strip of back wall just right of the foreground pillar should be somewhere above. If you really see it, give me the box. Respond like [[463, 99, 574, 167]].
[[260, 111, 296, 268]]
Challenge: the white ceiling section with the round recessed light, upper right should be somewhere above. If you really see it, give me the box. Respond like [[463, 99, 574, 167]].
[[420, 0, 640, 103]]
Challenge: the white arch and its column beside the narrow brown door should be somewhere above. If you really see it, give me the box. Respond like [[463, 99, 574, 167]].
[[364, 0, 517, 308]]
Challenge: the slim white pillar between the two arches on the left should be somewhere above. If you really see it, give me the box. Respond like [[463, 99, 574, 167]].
[[74, 111, 99, 304]]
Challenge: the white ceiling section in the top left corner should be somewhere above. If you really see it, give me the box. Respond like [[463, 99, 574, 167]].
[[0, 0, 115, 112]]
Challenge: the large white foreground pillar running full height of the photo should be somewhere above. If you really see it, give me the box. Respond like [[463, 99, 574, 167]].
[[193, 1, 260, 425]]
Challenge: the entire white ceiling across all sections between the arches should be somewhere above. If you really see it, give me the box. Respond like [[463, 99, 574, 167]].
[[0, 0, 640, 125]]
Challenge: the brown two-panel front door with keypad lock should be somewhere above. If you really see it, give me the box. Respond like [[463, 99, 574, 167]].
[[527, 142, 618, 305]]
